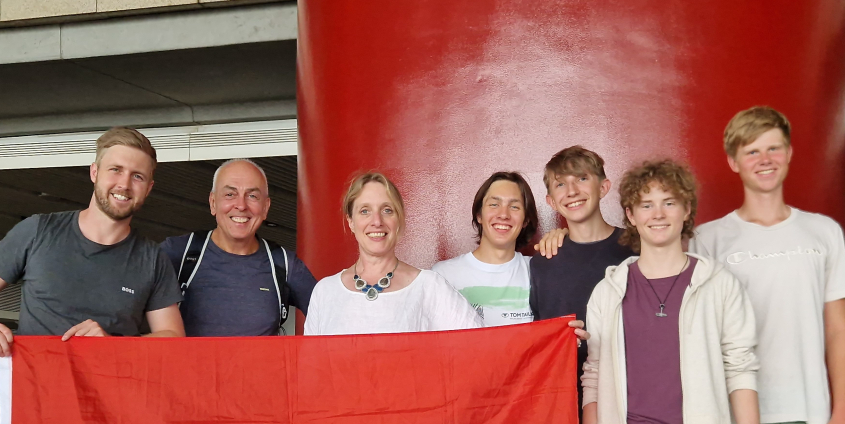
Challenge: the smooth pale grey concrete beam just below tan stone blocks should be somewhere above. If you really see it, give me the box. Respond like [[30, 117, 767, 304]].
[[0, 2, 298, 64]]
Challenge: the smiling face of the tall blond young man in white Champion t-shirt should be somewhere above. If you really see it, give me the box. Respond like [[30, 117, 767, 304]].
[[728, 128, 792, 193]]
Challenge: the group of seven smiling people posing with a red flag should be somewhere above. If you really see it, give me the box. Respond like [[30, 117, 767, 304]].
[[0, 107, 845, 424]]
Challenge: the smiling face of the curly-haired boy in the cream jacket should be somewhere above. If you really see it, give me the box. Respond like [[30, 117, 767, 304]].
[[625, 183, 690, 249]]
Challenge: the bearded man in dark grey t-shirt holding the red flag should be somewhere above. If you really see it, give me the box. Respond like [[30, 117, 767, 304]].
[[0, 128, 185, 356]]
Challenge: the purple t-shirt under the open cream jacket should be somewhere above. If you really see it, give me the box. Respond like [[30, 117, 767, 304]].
[[622, 257, 697, 424]]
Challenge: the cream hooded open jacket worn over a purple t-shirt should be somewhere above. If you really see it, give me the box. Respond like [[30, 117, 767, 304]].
[[581, 254, 759, 424]]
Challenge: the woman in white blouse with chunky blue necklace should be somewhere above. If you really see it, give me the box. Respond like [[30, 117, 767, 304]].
[[305, 172, 482, 335]]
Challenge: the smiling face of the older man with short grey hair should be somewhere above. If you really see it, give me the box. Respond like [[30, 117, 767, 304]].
[[208, 162, 270, 241]]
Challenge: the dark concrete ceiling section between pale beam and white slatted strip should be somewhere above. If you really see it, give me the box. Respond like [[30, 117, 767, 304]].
[[0, 40, 296, 136]]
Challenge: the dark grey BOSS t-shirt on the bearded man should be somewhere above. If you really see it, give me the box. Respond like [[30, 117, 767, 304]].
[[0, 211, 182, 336]]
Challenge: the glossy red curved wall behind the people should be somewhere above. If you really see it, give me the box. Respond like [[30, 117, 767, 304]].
[[297, 0, 845, 277]]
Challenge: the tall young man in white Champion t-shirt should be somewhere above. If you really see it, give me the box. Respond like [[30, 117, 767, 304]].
[[689, 107, 845, 424]]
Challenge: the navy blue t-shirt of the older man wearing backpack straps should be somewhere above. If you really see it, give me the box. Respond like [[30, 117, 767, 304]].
[[161, 235, 317, 337]]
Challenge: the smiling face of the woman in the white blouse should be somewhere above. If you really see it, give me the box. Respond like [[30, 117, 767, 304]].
[[346, 181, 401, 256]]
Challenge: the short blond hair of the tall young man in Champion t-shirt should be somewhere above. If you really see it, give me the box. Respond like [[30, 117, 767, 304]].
[[724, 106, 792, 158]]
